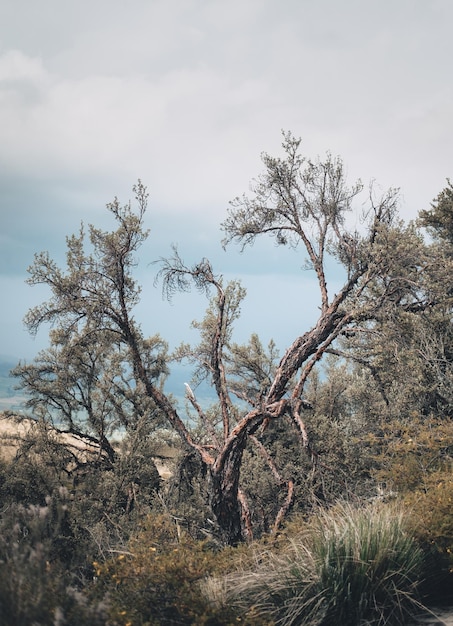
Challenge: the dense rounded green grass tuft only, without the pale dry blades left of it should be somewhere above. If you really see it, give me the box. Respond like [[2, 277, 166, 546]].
[[309, 505, 424, 624]]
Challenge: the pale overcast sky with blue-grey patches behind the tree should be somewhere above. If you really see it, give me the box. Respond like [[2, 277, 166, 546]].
[[0, 0, 453, 359]]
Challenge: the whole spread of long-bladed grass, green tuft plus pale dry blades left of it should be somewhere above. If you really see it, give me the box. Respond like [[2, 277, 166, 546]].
[[211, 504, 424, 626]]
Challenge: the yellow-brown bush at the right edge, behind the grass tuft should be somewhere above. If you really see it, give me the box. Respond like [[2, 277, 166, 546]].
[[364, 413, 453, 602]]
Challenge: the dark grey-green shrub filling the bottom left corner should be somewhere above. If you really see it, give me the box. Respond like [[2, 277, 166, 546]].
[[0, 499, 105, 626]]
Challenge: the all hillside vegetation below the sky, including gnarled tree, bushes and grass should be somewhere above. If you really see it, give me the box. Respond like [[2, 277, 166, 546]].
[[0, 139, 453, 626]]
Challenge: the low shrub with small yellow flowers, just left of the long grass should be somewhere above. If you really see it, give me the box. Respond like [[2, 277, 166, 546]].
[[94, 515, 269, 626]]
